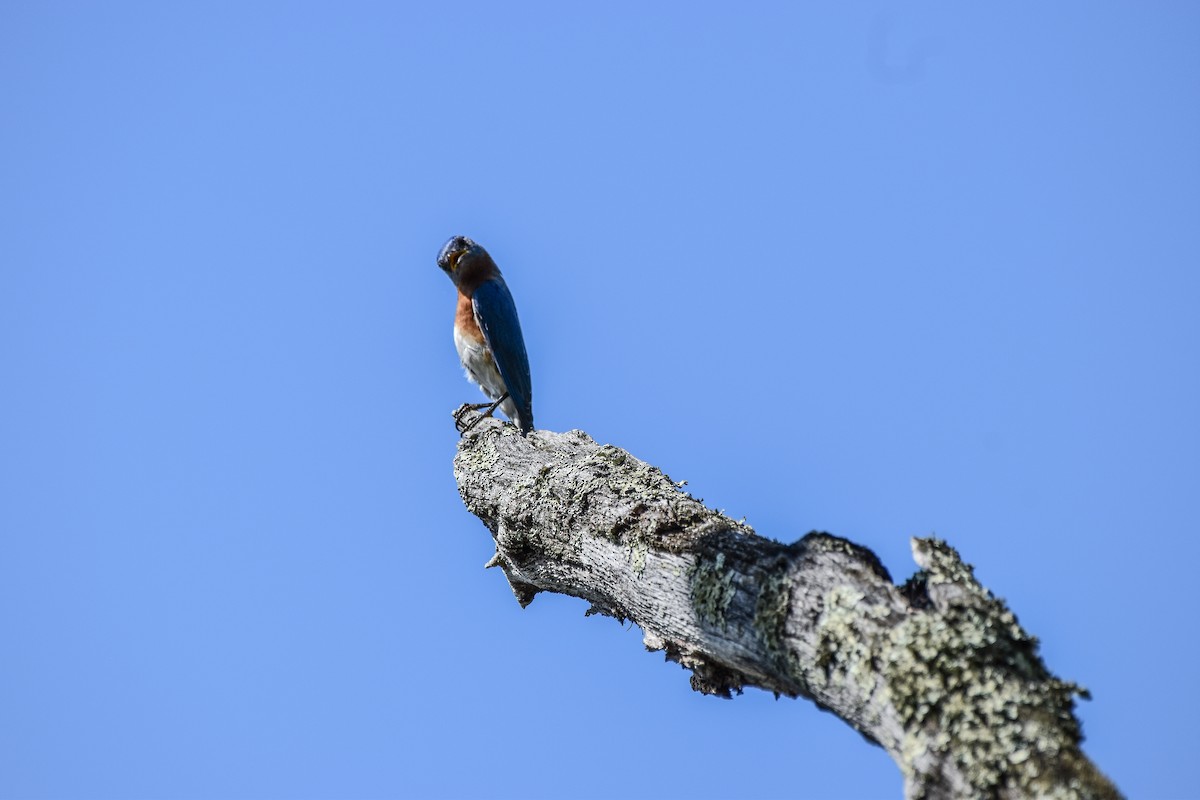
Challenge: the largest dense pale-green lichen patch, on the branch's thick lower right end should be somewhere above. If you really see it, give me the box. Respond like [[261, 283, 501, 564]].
[[880, 540, 1099, 796]]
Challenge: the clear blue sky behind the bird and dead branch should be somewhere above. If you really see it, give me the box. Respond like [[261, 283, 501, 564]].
[[0, 1, 1200, 799]]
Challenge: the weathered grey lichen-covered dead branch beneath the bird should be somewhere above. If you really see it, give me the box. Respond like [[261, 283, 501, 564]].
[[454, 409, 1120, 798]]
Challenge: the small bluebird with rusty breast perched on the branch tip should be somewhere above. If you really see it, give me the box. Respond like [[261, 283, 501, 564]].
[[438, 236, 533, 435]]
